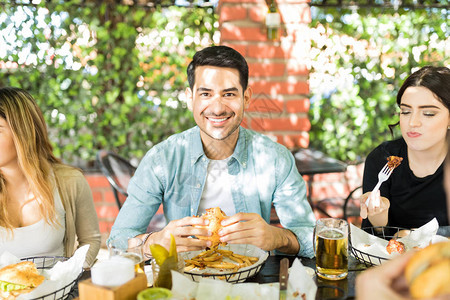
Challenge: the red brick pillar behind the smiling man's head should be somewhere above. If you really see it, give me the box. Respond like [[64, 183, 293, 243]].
[[218, 0, 311, 148]]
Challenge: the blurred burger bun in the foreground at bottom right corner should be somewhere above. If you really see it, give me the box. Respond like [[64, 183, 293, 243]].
[[405, 241, 450, 299]]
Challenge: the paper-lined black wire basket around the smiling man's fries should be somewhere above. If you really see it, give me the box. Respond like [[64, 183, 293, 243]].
[[179, 244, 269, 282]]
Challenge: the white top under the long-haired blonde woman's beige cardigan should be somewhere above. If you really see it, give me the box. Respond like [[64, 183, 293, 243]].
[[0, 186, 66, 258]]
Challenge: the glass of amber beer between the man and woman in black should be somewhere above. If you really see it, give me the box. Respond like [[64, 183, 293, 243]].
[[314, 218, 348, 280]]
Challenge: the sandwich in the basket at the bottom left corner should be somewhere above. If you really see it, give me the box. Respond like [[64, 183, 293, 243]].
[[0, 261, 45, 299]]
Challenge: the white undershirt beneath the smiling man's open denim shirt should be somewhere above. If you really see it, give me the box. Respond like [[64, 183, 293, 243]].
[[198, 157, 236, 216]]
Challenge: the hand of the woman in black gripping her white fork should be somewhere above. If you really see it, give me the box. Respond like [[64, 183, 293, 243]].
[[359, 191, 391, 226]]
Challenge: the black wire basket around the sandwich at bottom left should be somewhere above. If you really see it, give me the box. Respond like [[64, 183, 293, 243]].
[[21, 256, 82, 300]]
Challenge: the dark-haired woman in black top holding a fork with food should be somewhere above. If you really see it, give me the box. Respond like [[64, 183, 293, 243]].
[[360, 66, 450, 229]]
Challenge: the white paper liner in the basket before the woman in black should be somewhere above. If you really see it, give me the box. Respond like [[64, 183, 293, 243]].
[[350, 218, 445, 264]]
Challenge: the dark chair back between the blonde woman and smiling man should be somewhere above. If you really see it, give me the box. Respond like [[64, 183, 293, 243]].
[[97, 150, 136, 209]]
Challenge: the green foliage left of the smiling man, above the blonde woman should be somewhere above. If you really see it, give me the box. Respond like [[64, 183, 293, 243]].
[[0, 0, 218, 167]]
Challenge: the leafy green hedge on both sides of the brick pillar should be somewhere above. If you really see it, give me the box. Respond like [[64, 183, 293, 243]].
[[0, 0, 450, 168]]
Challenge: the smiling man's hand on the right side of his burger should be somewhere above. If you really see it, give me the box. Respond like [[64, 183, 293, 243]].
[[219, 213, 299, 254]]
